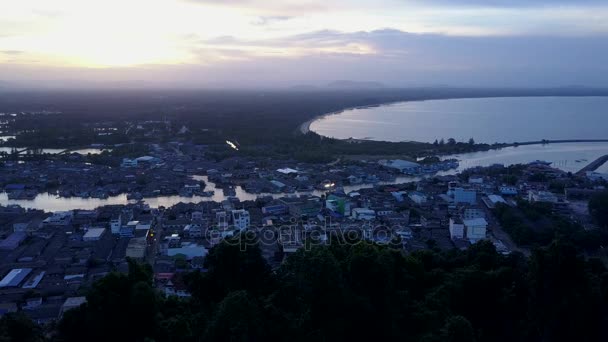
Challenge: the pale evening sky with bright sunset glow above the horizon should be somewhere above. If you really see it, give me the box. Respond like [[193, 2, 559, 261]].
[[0, 0, 608, 88]]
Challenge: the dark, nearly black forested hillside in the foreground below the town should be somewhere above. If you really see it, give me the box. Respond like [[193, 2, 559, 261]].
[[0, 234, 608, 342]]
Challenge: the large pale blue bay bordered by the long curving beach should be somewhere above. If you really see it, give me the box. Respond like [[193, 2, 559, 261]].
[[310, 97, 608, 143]]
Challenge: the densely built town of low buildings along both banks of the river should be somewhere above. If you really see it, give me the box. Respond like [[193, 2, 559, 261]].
[[0, 138, 608, 325]]
